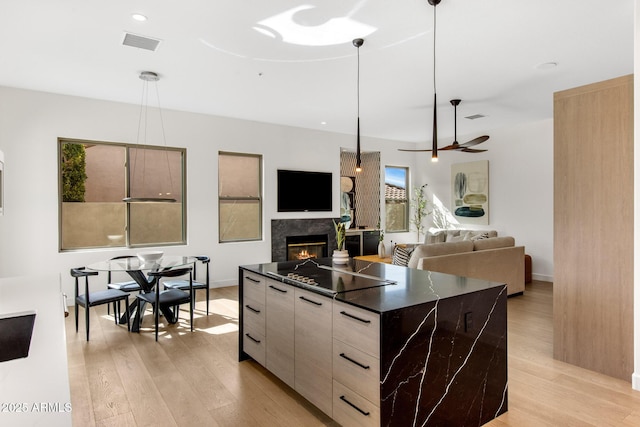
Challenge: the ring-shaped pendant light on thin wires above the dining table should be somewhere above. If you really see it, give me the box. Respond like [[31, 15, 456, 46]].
[[122, 71, 177, 203]]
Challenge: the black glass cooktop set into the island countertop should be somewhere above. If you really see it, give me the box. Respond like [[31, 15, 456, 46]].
[[266, 260, 396, 295]]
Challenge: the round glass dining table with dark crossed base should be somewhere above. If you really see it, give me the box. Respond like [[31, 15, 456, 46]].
[[86, 255, 197, 332]]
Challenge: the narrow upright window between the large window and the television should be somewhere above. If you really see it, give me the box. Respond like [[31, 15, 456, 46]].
[[218, 152, 262, 242]]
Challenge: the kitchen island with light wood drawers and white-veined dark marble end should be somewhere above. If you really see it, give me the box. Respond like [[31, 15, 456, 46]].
[[239, 258, 507, 426]]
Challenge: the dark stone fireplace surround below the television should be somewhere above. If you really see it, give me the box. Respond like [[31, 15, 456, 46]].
[[271, 218, 337, 262]]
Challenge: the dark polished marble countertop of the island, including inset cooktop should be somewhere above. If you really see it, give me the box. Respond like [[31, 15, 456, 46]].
[[240, 258, 506, 313]]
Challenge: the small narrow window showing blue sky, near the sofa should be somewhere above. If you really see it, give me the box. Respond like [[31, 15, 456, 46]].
[[384, 166, 409, 233]]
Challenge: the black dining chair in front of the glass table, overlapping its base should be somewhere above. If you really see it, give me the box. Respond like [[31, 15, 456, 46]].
[[137, 267, 194, 341]]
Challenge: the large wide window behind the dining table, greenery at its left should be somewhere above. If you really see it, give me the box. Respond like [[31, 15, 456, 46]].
[[58, 139, 186, 250]]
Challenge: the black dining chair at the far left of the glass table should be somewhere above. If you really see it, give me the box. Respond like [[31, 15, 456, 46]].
[[71, 267, 131, 341]]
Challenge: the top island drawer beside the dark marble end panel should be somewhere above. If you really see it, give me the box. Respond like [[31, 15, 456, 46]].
[[333, 301, 380, 359]]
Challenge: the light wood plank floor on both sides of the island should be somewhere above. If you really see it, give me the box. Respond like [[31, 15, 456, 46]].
[[67, 281, 640, 427]]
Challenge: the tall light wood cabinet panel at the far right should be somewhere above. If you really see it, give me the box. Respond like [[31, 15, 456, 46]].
[[553, 76, 634, 381]]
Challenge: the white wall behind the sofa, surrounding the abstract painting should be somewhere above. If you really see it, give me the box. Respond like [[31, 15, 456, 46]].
[[412, 120, 553, 281]]
